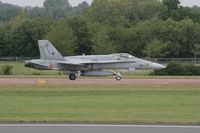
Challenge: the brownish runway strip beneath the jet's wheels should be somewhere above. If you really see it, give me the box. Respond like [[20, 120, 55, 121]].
[[0, 77, 200, 86]]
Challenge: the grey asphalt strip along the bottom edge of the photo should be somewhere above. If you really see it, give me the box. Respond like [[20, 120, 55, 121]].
[[0, 124, 200, 133]]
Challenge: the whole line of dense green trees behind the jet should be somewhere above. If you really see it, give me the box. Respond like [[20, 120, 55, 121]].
[[0, 0, 200, 58]]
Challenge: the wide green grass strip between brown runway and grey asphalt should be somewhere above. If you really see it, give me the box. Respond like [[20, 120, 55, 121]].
[[0, 86, 200, 124]]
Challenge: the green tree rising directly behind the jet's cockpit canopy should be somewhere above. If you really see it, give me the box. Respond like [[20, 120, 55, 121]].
[[115, 19, 163, 57]]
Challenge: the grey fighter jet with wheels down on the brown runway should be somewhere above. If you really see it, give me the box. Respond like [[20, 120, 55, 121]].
[[25, 40, 165, 80]]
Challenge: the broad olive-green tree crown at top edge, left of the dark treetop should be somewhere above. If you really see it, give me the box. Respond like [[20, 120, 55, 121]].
[[88, 0, 167, 27]]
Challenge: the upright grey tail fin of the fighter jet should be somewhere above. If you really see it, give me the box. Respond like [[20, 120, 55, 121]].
[[38, 40, 65, 60]]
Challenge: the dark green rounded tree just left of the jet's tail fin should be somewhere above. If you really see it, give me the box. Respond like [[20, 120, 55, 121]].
[[7, 18, 50, 57]]
